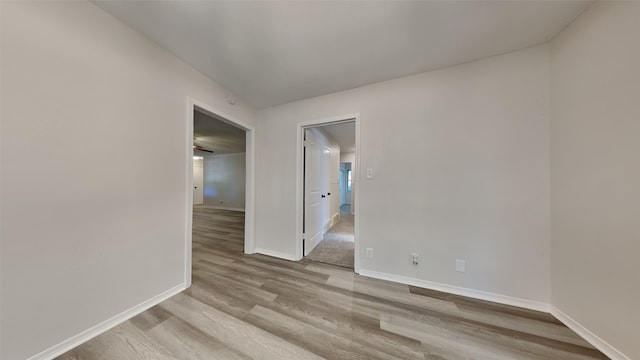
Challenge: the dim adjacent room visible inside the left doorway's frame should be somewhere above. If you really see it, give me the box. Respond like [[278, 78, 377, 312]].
[[192, 109, 246, 268]]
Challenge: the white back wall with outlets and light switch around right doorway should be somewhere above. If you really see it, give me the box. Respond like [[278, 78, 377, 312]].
[[256, 45, 550, 306]]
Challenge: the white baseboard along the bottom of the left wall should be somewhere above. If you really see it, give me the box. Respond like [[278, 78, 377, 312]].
[[27, 284, 185, 360]]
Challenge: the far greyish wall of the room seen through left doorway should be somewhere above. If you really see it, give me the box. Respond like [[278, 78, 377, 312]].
[[204, 153, 246, 210]]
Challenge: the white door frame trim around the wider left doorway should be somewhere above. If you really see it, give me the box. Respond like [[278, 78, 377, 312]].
[[184, 97, 256, 287]]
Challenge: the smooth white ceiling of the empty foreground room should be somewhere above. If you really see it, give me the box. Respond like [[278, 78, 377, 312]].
[[94, 0, 592, 108]]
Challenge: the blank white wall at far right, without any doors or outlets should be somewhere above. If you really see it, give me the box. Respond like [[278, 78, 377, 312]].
[[550, 2, 640, 359]]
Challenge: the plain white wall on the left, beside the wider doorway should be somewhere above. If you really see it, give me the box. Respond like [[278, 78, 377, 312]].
[[0, 1, 254, 360]]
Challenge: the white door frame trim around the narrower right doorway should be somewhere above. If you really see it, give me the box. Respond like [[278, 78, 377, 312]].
[[296, 113, 360, 273]]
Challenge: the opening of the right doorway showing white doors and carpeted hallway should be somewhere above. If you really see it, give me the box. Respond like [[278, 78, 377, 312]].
[[302, 119, 356, 269]]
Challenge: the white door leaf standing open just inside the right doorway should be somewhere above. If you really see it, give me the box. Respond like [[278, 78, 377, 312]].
[[304, 129, 325, 256]]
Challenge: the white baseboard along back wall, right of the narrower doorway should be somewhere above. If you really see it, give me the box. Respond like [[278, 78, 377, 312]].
[[359, 269, 550, 313]]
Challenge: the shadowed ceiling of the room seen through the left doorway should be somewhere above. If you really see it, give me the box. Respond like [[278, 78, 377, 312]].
[[193, 111, 246, 155]]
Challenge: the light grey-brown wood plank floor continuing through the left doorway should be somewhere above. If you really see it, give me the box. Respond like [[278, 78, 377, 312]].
[[59, 208, 606, 360]]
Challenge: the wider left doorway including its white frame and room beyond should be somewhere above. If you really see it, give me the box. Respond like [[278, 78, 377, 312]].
[[185, 99, 255, 286]]
